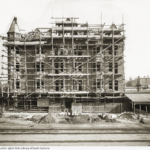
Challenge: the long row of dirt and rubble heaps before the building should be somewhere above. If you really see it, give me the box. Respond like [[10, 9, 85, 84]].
[[3, 112, 150, 124]]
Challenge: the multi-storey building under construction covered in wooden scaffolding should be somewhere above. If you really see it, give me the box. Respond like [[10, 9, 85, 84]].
[[2, 17, 129, 113]]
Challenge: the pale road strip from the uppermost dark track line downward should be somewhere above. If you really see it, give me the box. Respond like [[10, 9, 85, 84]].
[[0, 129, 150, 146]]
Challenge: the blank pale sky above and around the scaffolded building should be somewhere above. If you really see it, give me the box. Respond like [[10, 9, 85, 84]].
[[0, 0, 150, 80]]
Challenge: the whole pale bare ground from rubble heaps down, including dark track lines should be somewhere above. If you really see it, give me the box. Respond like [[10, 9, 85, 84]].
[[0, 123, 150, 146]]
